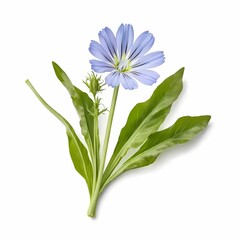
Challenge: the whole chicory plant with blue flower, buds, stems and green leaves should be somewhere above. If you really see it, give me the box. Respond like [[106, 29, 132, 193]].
[[26, 24, 211, 217]]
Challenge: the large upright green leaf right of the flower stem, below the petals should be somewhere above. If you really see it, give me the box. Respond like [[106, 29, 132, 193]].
[[102, 68, 184, 184]]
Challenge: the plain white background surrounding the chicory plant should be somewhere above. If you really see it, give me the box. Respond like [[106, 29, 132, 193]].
[[0, 0, 240, 240]]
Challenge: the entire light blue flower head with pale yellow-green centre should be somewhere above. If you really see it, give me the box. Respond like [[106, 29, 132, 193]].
[[89, 24, 164, 89]]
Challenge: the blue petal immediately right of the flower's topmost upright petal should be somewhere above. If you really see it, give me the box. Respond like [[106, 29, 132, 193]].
[[129, 32, 155, 61]]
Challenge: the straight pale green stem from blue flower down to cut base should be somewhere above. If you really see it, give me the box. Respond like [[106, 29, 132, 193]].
[[88, 86, 119, 217]]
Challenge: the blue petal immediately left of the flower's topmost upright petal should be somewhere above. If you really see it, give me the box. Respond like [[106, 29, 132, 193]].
[[98, 27, 117, 59]]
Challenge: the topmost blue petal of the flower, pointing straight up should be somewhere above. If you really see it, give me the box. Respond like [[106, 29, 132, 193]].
[[117, 24, 134, 59]]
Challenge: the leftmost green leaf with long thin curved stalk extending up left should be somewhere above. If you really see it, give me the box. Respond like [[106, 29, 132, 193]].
[[26, 80, 92, 194]]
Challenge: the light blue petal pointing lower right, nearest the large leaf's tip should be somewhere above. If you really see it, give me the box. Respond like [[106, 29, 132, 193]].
[[130, 70, 160, 85]]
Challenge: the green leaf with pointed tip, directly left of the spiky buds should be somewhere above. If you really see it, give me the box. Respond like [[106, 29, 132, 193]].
[[52, 62, 94, 158]]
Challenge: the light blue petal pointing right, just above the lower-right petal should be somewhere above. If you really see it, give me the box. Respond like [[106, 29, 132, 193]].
[[132, 51, 164, 71]]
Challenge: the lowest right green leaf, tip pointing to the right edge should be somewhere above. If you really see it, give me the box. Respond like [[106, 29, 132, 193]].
[[102, 115, 211, 188]]
